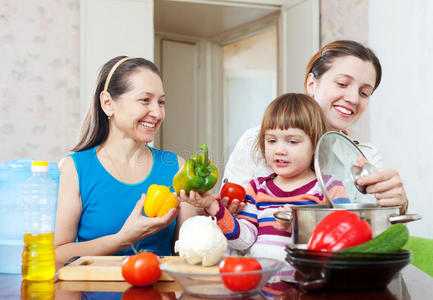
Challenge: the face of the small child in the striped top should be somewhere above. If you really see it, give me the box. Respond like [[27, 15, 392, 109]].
[[265, 128, 314, 179]]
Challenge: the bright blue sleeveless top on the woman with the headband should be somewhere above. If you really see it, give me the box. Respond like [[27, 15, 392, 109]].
[[70, 146, 179, 255]]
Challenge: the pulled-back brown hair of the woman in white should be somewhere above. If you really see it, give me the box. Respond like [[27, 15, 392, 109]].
[[304, 40, 382, 91]]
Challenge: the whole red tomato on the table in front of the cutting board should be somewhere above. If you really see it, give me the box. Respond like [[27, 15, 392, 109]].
[[122, 252, 162, 286]]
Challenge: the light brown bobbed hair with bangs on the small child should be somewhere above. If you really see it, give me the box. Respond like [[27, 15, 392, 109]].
[[257, 93, 326, 156]]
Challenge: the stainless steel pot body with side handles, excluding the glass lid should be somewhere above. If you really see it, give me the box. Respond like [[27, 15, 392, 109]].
[[274, 203, 421, 244]]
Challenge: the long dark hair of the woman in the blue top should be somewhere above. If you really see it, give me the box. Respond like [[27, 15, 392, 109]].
[[72, 56, 161, 152]]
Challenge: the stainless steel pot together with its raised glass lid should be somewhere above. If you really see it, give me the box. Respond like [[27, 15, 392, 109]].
[[274, 131, 421, 244]]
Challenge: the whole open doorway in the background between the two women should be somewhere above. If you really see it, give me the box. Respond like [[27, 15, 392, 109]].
[[154, 0, 279, 187]]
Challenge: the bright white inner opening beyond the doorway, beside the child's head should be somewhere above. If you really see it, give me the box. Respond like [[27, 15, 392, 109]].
[[223, 26, 278, 153]]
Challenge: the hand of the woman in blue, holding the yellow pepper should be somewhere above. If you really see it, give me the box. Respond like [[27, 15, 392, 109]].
[[117, 194, 179, 245]]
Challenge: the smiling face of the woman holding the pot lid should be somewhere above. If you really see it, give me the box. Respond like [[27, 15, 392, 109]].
[[307, 55, 376, 130]]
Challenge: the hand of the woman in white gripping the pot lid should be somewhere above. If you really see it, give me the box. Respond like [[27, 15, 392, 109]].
[[356, 169, 408, 213]]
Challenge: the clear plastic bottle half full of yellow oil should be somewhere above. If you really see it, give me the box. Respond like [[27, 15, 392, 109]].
[[21, 161, 57, 281]]
